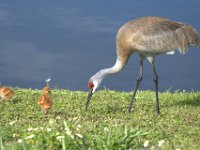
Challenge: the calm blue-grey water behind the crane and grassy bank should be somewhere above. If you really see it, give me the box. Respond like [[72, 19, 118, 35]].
[[0, 0, 200, 91]]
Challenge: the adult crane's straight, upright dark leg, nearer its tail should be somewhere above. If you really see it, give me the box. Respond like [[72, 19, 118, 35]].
[[148, 57, 160, 114]]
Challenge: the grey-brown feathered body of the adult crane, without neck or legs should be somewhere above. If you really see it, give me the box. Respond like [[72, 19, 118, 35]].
[[116, 17, 200, 62]]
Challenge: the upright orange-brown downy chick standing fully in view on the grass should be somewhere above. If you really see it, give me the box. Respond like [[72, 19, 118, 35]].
[[38, 86, 53, 115]]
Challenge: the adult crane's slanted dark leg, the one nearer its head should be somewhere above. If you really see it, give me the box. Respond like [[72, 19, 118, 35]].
[[128, 56, 144, 112]]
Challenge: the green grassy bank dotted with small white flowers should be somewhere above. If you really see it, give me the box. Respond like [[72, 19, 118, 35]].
[[0, 88, 200, 150]]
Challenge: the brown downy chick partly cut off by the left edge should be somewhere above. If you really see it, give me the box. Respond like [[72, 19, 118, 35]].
[[0, 86, 15, 101]]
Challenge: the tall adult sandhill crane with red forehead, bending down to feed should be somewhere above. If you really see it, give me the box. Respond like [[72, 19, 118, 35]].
[[86, 17, 200, 114]]
